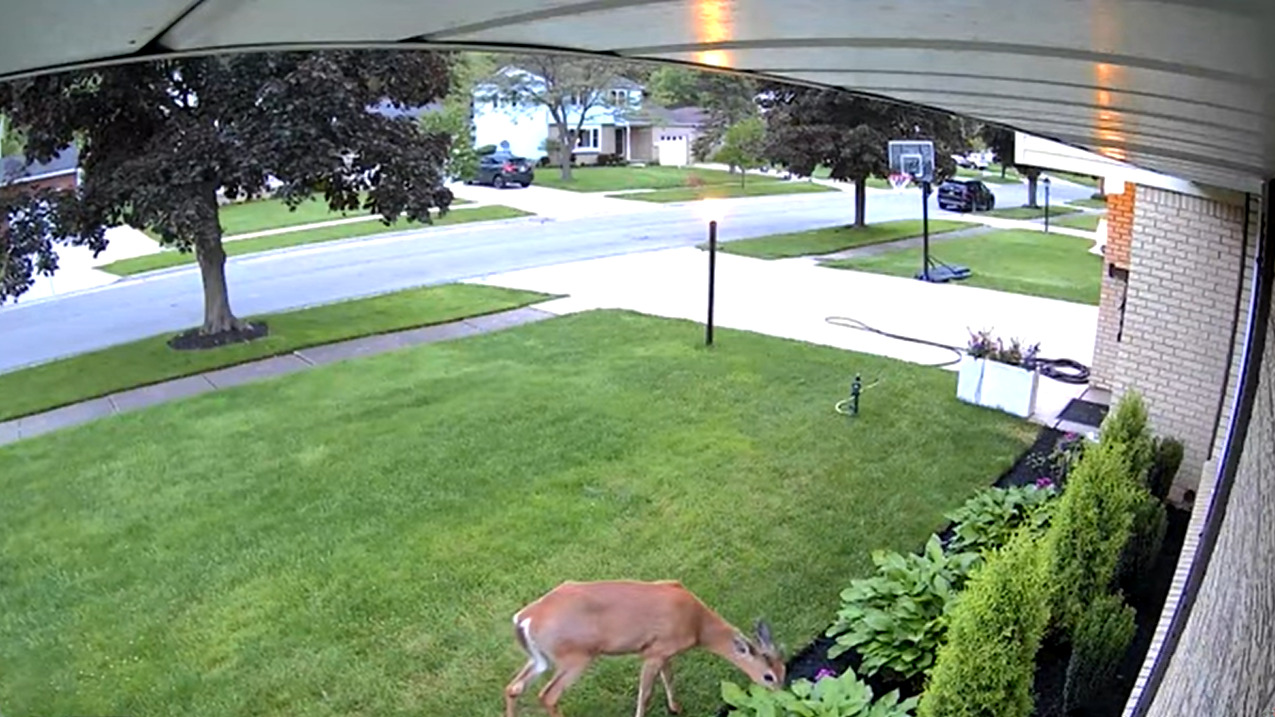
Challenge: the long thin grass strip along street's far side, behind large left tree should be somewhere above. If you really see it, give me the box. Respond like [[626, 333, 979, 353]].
[[98, 204, 530, 277]]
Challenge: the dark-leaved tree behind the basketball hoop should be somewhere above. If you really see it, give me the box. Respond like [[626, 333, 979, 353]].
[[761, 84, 965, 227]]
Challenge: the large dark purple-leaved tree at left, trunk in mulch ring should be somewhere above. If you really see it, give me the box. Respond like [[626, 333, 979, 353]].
[[0, 51, 451, 334]]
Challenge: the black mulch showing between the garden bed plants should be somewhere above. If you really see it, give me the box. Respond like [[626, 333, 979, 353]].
[[718, 427, 1190, 717]]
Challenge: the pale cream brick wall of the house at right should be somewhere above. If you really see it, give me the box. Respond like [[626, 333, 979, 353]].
[[1095, 186, 1260, 500]]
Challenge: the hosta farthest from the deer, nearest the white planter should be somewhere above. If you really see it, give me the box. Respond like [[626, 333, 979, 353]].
[[947, 482, 1058, 552]]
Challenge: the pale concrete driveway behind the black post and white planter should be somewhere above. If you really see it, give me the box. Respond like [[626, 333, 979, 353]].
[[470, 242, 1098, 426]]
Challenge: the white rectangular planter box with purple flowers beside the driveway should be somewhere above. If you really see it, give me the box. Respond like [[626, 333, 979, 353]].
[[956, 330, 1040, 418]]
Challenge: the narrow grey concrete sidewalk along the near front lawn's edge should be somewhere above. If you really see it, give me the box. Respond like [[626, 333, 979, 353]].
[[0, 306, 553, 445]]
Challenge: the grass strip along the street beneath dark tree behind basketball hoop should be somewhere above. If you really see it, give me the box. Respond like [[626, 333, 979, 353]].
[[718, 219, 978, 259]]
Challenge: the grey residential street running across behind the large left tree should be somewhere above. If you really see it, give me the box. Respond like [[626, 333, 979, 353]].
[[0, 181, 1091, 371]]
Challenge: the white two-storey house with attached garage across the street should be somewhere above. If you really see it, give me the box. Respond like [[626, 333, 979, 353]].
[[473, 68, 704, 166]]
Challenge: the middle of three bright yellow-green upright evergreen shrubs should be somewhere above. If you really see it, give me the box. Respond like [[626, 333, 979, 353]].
[[1044, 436, 1149, 634]]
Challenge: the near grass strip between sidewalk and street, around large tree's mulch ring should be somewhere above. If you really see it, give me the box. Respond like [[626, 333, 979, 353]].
[[0, 283, 548, 421]]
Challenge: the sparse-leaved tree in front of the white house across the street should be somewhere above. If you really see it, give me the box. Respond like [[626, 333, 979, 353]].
[[478, 54, 630, 181]]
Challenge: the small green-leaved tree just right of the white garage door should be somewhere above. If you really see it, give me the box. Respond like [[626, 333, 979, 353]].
[[648, 65, 757, 163]]
